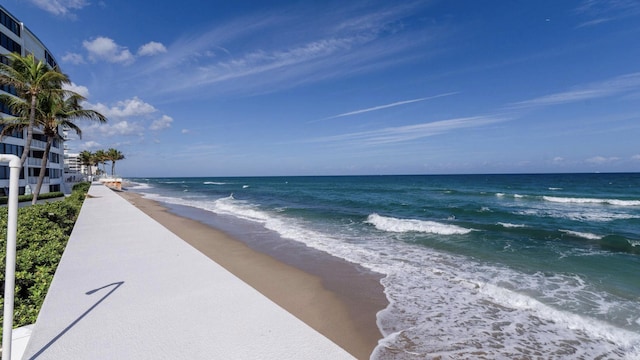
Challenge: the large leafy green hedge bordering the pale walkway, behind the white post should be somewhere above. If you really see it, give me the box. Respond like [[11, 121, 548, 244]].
[[0, 183, 91, 341]]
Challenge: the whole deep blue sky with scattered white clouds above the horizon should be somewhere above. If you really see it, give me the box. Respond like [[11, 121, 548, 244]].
[[3, 0, 640, 177]]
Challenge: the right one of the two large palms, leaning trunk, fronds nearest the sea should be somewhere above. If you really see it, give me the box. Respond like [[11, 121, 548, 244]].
[[32, 91, 107, 204]]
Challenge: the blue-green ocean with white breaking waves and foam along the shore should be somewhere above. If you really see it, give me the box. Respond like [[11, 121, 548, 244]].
[[127, 174, 640, 359]]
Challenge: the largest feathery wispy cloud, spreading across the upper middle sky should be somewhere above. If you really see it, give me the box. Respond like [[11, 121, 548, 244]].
[[125, 3, 440, 98]]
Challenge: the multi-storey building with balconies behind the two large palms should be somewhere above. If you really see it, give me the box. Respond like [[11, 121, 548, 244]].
[[0, 6, 66, 195]]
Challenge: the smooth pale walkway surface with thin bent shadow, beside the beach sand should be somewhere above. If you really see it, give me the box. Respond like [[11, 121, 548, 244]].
[[23, 183, 353, 359]]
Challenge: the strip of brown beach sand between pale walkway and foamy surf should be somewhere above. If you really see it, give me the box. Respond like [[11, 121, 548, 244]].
[[119, 191, 388, 359]]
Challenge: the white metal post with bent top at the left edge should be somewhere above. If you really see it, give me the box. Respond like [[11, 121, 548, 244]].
[[0, 154, 21, 360]]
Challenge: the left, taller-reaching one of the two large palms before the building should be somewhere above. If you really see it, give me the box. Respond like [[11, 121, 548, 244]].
[[0, 53, 71, 167]]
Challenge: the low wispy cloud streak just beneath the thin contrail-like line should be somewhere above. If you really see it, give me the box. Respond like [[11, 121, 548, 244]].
[[311, 116, 509, 146]]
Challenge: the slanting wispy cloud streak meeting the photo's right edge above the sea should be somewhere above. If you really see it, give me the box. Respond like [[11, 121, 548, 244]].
[[508, 73, 640, 109]]
